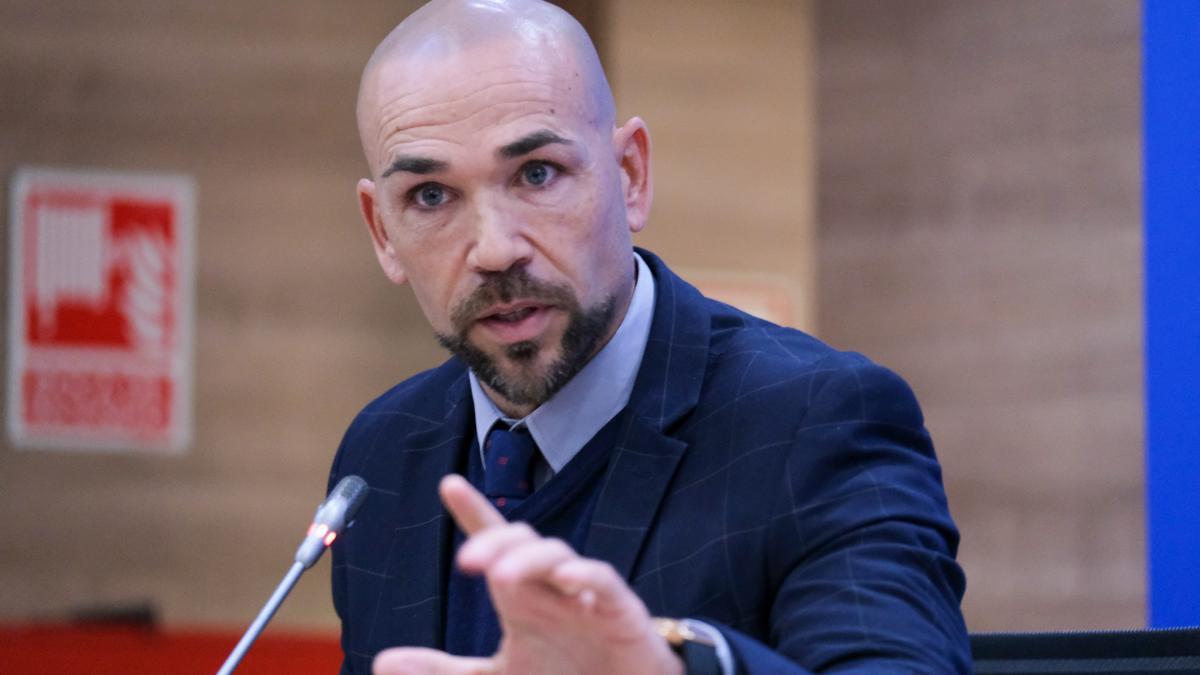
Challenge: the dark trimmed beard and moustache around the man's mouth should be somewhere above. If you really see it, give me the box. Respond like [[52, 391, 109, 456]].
[[438, 268, 616, 407]]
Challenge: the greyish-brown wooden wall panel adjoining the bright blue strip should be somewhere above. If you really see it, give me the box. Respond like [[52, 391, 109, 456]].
[[817, 0, 1145, 629]]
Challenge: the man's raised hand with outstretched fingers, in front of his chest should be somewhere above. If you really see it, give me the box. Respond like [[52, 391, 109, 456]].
[[373, 476, 683, 675]]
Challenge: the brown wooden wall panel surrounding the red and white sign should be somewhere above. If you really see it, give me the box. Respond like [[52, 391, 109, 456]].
[[0, 0, 429, 629]]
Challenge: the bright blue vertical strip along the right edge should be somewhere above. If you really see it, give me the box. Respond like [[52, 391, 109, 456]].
[[1142, 0, 1200, 626]]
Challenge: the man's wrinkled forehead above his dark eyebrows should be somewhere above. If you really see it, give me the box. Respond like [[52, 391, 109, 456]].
[[362, 47, 592, 163]]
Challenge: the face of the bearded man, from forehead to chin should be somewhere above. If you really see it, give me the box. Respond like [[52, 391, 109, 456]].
[[360, 46, 648, 410]]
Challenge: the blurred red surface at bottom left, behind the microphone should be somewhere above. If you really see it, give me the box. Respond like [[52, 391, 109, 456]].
[[0, 625, 342, 675]]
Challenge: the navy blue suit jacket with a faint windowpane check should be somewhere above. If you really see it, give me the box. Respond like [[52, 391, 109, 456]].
[[330, 251, 970, 674]]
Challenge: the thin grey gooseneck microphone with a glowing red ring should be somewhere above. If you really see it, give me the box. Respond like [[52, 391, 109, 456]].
[[217, 476, 367, 675]]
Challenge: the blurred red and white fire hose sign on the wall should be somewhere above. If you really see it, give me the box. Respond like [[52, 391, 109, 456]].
[[7, 168, 196, 452]]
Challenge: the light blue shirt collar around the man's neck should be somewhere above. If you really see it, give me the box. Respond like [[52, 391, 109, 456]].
[[469, 252, 654, 473]]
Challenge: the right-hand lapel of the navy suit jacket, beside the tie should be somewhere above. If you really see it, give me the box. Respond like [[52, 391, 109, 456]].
[[583, 249, 709, 579]]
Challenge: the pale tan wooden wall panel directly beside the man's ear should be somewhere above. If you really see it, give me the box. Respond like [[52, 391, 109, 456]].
[[604, 0, 816, 328]]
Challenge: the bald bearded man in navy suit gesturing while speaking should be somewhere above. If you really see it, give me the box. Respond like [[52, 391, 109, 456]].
[[331, 0, 970, 675]]
